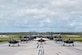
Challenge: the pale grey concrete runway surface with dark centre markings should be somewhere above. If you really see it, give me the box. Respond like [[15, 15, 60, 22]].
[[0, 40, 82, 55]]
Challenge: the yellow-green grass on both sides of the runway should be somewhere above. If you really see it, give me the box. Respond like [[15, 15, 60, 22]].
[[0, 35, 82, 42]]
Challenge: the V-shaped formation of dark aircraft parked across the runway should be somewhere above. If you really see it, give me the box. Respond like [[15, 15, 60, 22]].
[[9, 36, 74, 46]]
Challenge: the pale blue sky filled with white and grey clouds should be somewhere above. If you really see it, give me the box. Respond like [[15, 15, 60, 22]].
[[0, 0, 82, 32]]
